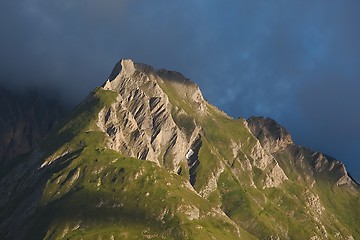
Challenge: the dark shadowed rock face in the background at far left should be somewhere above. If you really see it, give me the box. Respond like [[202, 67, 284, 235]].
[[0, 87, 64, 165]]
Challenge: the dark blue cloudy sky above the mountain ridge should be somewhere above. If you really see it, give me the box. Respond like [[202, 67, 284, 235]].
[[0, 0, 360, 180]]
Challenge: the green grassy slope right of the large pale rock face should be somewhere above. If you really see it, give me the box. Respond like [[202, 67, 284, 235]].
[[162, 78, 360, 239]]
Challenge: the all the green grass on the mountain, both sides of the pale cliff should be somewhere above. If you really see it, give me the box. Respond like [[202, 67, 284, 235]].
[[3, 78, 360, 239]]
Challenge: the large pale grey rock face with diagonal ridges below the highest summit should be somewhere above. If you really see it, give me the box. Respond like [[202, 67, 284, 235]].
[[97, 60, 206, 180]]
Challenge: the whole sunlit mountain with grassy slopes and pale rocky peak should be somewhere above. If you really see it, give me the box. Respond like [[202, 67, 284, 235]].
[[0, 60, 360, 240]]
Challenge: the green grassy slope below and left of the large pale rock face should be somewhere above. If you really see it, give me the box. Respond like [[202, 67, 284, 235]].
[[26, 89, 252, 239]]
